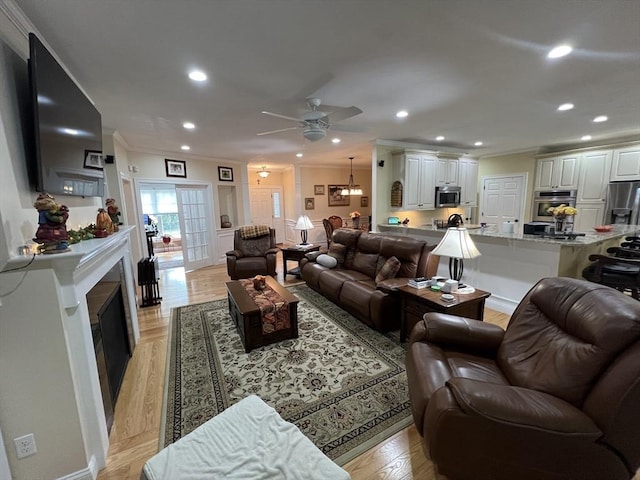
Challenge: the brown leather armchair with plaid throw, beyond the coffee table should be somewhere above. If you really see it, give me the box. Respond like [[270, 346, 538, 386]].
[[227, 228, 280, 280]]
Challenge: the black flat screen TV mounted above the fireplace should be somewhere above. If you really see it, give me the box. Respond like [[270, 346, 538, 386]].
[[28, 33, 104, 197]]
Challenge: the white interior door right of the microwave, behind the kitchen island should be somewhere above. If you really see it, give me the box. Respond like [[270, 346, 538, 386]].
[[480, 175, 525, 231]]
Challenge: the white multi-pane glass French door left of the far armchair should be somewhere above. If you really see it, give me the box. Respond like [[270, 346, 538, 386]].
[[176, 185, 215, 272]]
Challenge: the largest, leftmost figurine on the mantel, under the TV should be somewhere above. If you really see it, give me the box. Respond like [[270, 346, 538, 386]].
[[33, 193, 71, 253]]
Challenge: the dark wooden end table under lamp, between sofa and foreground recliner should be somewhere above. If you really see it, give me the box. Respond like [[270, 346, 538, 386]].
[[398, 285, 491, 342]]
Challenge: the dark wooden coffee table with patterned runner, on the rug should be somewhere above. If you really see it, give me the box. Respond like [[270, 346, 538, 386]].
[[227, 277, 299, 353]]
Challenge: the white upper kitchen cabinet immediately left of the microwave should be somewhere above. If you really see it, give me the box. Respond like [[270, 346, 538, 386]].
[[393, 152, 437, 210]]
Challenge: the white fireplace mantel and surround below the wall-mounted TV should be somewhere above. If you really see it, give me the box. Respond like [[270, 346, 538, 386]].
[[0, 227, 140, 479]]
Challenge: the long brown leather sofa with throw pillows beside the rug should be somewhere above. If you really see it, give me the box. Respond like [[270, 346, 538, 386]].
[[300, 228, 440, 332]]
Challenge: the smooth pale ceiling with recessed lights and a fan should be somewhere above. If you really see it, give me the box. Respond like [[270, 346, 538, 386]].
[[10, 0, 640, 168]]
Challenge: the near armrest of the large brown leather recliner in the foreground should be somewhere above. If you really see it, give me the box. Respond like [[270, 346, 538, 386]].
[[446, 377, 602, 441]]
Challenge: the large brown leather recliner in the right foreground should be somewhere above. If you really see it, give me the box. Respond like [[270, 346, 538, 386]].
[[406, 278, 640, 480]]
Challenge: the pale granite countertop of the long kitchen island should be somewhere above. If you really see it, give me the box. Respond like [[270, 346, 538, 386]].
[[378, 224, 640, 246]]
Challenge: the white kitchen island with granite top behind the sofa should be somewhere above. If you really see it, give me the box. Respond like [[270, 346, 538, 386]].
[[377, 225, 640, 314]]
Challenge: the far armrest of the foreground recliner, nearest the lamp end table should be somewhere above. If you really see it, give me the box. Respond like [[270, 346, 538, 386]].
[[409, 312, 504, 355]]
